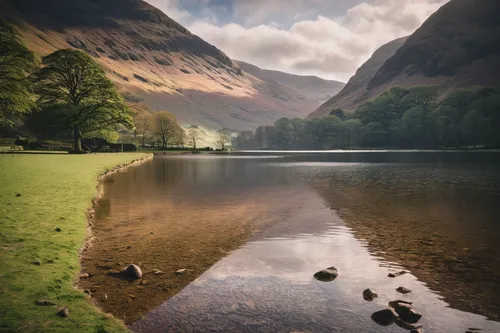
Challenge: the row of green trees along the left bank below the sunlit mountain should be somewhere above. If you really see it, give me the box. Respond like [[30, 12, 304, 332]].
[[0, 20, 196, 152]]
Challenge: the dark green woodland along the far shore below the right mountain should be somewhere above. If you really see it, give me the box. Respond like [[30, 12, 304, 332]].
[[233, 86, 500, 150]]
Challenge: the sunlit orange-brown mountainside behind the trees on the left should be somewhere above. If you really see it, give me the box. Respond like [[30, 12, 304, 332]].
[[0, 0, 318, 130]]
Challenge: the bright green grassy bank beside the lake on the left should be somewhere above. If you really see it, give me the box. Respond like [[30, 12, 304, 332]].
[[0, 153, 145, 333]]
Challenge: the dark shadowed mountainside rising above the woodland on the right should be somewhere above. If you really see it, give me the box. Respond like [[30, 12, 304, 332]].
[[311, 0, 500, 116]]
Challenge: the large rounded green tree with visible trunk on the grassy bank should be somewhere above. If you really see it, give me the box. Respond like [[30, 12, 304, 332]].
[[35, 49, 133, 152]]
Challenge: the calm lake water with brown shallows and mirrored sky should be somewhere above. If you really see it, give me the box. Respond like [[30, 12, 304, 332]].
[[84, 152, 500, 333]]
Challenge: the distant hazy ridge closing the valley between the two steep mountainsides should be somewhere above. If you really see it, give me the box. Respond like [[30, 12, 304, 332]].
[[235, 61, 345, 103]]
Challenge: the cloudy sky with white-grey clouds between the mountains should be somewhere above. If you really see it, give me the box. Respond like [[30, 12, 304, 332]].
[[146, 0, 448, 81]]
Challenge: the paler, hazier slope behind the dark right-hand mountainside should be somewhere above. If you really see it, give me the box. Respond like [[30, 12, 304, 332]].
[[310, 37, 408, 117]]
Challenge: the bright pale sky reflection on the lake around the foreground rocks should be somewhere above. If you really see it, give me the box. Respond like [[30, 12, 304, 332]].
[[132, 189, 500, 332]]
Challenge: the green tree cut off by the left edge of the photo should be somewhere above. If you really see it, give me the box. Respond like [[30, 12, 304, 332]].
[[0, 19, 35, 126]]
